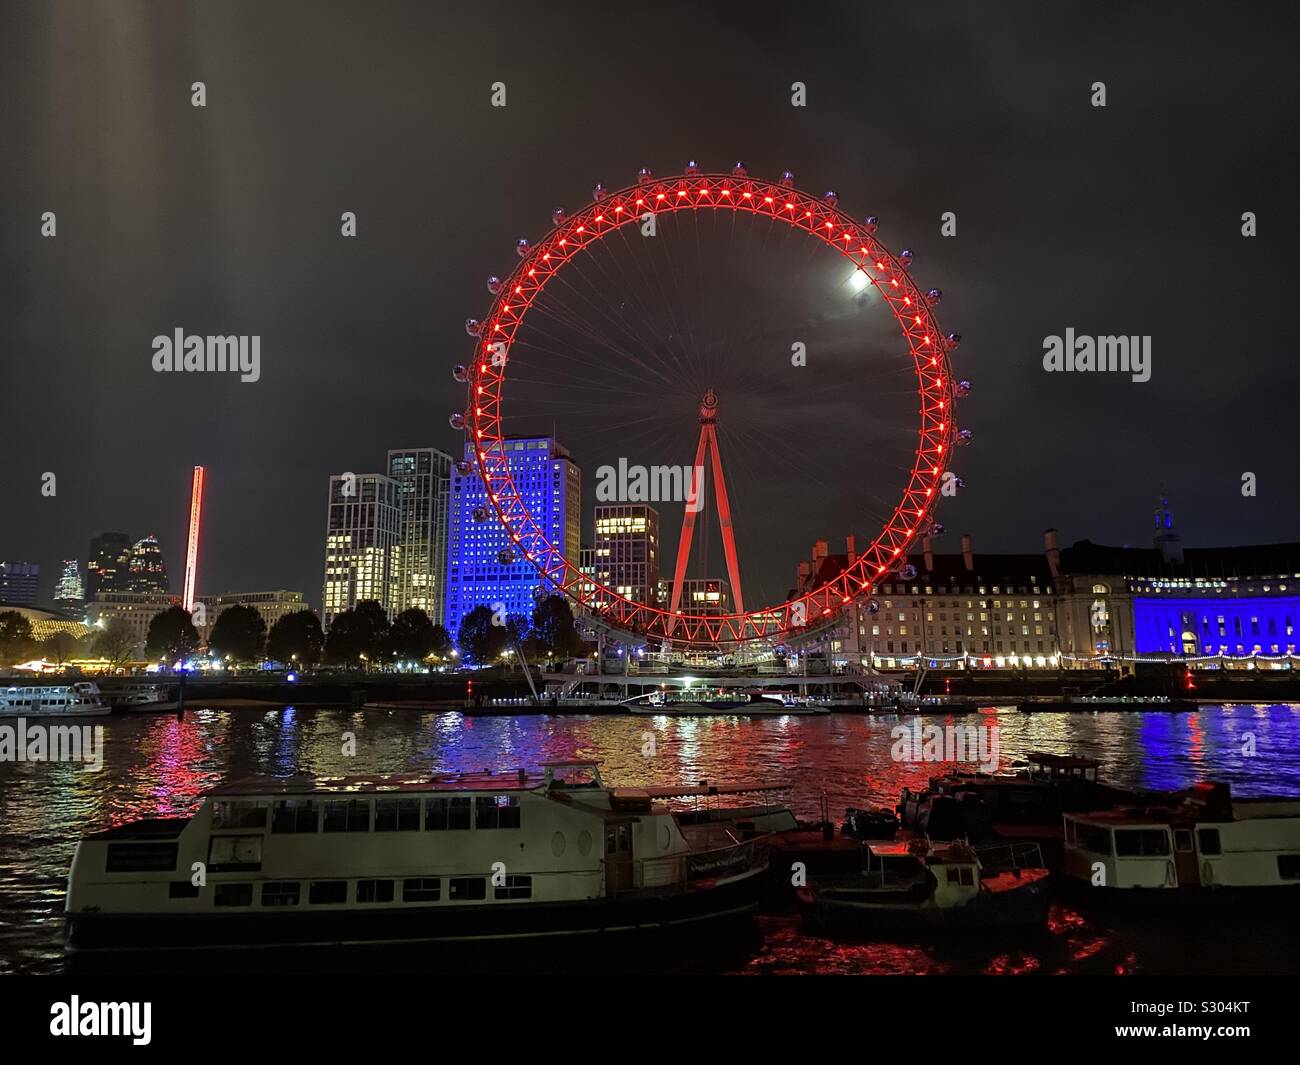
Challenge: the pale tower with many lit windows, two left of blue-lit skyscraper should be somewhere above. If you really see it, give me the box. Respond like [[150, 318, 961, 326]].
[[321, 473, 400, 628]]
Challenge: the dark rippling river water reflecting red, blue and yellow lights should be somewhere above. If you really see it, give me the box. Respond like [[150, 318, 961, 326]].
[[0, 705, 1300, 973]]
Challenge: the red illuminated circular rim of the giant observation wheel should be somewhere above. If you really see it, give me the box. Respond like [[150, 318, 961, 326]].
[[464, 174, 957, 648]]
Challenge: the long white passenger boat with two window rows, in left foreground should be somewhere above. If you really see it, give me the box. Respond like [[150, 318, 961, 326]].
[[66, 762, 767, 952]]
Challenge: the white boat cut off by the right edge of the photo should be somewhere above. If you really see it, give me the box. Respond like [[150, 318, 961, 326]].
[[1065, 784, 1300, 905]]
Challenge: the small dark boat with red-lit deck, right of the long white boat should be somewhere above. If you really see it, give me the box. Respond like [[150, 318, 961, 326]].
[[794, 839, 1049, 930]]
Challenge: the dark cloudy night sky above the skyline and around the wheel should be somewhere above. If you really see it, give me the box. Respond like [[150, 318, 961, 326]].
[[0, 0, 1300, 606]]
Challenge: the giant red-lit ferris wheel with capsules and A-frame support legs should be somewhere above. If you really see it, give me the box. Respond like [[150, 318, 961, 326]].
[[451, 163, 970, 649]]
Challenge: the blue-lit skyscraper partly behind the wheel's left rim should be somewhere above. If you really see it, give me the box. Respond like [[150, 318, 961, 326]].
[[443, 437, 582, 636]]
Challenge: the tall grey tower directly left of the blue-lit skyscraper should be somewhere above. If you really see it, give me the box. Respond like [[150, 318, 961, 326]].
[[389, 447, 452, 624]]
